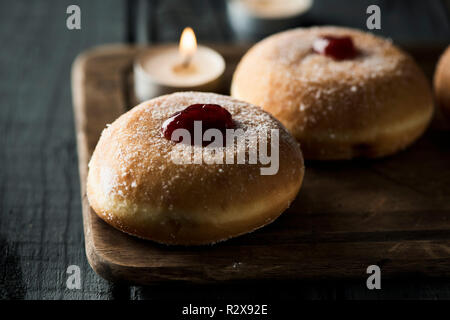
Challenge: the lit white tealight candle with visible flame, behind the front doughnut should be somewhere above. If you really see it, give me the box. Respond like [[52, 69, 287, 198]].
[[134, 28, 225, 101]]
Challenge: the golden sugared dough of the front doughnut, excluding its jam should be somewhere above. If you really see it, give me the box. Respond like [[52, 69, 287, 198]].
[[87, 92, 304, 245]]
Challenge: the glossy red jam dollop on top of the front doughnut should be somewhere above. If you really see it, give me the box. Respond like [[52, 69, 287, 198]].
[[161, 104, 234, 146]]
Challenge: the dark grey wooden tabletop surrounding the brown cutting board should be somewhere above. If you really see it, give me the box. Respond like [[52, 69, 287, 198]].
[[0, 0, 450, 301]]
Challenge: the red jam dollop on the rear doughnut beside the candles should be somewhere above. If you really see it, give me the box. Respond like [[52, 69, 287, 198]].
[[313, 36, 358, 60]]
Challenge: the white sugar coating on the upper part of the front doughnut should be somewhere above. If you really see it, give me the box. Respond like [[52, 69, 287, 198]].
[[91, 92, 301, 202]]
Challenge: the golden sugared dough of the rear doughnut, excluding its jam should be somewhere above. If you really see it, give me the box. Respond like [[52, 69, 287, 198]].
[[231, 27, 433, 160]]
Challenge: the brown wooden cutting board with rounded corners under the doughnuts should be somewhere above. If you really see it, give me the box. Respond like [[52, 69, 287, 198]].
[[72, 45, 450, 284]]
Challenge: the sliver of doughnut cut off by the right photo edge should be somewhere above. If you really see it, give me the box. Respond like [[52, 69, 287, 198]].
[[434, 46, 450, 119]]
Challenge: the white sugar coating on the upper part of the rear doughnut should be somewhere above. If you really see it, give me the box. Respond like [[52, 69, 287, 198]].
[[236, 27, 411, 116]]
